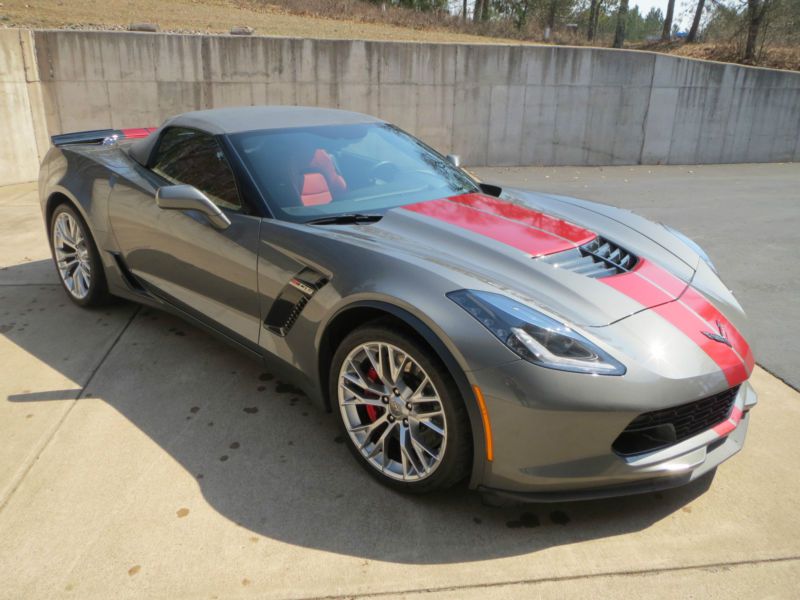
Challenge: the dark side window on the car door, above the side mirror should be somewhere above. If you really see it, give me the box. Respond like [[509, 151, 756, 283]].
[[153, 127, 242, 210]]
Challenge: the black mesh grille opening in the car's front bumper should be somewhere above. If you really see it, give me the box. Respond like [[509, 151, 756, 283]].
[[612, 386, 739, 456]]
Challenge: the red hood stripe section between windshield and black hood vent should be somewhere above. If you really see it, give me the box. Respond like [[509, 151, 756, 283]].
[[403, 194, 588, 256]]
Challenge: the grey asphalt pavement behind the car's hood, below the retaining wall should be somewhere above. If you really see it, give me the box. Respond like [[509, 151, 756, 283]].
[[476, 163, 800, 389]]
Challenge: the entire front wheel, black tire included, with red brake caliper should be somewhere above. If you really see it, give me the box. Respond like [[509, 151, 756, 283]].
[[330, 323, 471, 493]]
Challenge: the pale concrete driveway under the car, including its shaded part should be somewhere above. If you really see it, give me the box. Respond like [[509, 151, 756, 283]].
[[0, 167, 800, 599]]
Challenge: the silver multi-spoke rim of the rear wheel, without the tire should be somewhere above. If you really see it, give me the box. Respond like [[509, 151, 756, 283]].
[[53, 212, 92, 300]]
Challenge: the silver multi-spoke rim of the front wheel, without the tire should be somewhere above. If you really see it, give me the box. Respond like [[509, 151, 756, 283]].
[[338, 342, 447, 481]]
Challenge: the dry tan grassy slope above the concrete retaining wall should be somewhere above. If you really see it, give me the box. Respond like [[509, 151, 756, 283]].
[[0, 0, 800, 71]]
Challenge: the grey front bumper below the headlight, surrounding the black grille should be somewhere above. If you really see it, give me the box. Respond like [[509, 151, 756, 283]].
[[473, 363, 757, 502]]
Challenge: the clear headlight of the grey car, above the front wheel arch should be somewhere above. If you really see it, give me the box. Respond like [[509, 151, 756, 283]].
[[447, 290, 625, 375]]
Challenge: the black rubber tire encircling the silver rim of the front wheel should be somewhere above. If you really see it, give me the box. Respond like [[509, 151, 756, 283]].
[[329, 321, 472, 494]]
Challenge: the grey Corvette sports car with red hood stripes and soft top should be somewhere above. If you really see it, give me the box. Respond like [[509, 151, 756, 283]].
[[39, 107, 756, 501]]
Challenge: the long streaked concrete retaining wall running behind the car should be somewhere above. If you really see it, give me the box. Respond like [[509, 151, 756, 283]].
[[1, 31, 800, 184]]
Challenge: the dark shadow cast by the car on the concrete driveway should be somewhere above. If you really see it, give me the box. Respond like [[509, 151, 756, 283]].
[[0, 261, 713, 564]]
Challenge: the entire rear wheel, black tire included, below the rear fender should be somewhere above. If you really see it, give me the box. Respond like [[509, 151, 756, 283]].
[[50, 204, 109, 306]]
